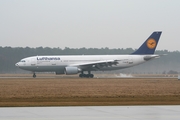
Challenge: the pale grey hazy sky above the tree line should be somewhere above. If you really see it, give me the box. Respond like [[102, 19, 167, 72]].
[[0, 0, 180, 51]]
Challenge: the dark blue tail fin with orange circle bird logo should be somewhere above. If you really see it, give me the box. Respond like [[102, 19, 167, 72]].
[[132, 31, 162, 55]]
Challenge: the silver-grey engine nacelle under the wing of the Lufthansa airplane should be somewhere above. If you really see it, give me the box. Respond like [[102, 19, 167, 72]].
[[64, 67, 81, 75]]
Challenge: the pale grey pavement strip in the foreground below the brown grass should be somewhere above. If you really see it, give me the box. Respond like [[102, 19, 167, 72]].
[[0, 105, 180, 120]]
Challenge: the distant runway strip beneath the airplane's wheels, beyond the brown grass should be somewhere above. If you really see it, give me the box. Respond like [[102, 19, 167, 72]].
[[0, 73, 178, 79]]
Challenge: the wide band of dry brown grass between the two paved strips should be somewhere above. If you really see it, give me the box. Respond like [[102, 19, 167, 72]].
[[0, 78, 180, 107]]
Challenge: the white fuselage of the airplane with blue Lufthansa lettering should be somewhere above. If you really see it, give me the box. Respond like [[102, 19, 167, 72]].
[[16, 55, 157, 74]]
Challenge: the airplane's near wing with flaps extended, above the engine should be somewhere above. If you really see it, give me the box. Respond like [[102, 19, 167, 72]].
[[69, 60, 120, 69]]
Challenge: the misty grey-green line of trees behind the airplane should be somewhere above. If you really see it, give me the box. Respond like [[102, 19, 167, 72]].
[[0, 47, 180, 74]]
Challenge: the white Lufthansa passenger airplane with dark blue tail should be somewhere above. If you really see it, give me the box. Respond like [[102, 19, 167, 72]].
[[15, 31, 162, 78]]
